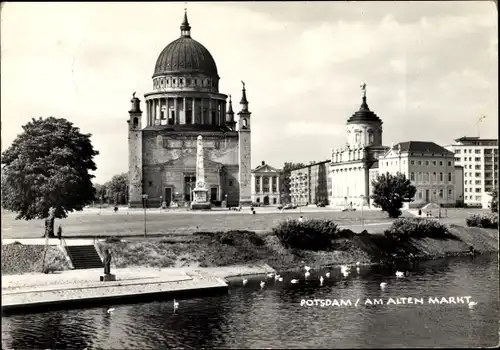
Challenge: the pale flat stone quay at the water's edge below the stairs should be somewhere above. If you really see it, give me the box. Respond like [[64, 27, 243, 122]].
[[2, 265, 274, 314]]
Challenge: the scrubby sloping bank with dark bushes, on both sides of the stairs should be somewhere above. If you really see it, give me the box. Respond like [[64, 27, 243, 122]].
[[2, 214, 498, 275]]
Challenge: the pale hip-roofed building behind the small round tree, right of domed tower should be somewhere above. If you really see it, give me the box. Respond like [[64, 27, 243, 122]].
[[376, 141, 463, 208]]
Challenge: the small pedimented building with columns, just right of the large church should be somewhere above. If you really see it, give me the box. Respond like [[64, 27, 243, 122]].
[[252, 161, 281, 205]]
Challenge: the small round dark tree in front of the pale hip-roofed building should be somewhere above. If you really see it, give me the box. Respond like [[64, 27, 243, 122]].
[[371, 172, 417, 218]]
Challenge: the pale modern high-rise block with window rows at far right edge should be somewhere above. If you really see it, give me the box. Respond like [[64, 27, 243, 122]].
[[446, 137, 498, 207]]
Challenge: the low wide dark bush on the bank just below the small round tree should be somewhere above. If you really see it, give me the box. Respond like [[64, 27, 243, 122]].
[[384, 218, 454, 241]]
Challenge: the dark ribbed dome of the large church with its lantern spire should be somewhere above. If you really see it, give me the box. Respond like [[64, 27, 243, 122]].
[[153, 13, 219, 78]]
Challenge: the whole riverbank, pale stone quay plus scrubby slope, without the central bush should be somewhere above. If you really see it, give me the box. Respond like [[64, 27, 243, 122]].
[[2, 219, 498, 312]]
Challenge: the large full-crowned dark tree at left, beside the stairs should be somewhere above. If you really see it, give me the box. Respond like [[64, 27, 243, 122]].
[[2, 117, 99, 237]]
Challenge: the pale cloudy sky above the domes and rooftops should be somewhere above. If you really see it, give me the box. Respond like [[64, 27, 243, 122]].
[[1, 1, 498, 183]]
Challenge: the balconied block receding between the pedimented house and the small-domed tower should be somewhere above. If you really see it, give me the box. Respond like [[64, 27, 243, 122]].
[[290, 160, 331, 205]]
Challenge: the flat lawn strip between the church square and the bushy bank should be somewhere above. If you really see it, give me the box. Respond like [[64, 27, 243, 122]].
[[2, 210, 398, 238]]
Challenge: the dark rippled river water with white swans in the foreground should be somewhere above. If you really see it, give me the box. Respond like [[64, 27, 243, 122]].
[[2, 254, 499, 349]]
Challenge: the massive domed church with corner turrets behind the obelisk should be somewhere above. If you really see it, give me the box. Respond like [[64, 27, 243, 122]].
[[127, 14, 252, 207]]
